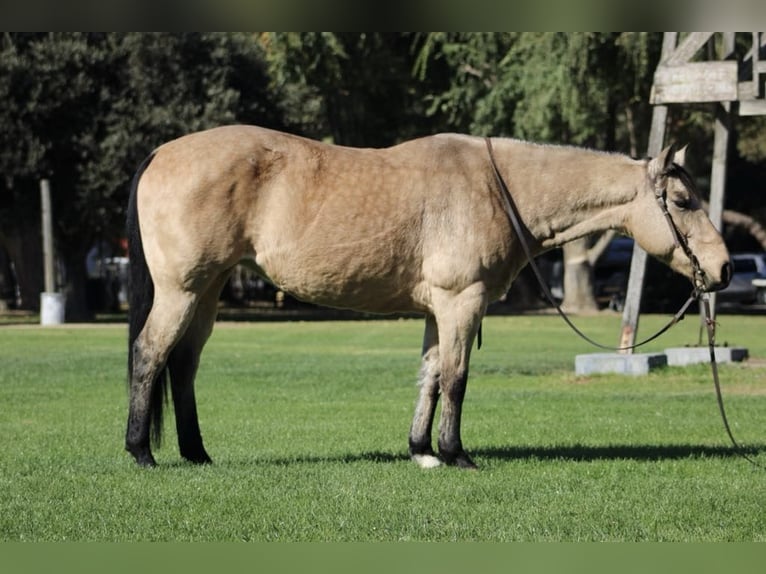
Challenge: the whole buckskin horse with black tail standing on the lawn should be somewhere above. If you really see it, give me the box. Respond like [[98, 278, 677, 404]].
[[126, 126, 731, 468]]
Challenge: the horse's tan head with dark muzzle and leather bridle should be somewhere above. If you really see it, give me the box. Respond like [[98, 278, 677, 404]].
[[629, 147, 732, 291]]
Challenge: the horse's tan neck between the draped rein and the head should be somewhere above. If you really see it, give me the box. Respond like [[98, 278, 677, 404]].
[[501, 142, 643, 249]]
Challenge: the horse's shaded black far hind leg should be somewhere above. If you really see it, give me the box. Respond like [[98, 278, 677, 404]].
[[168, 275, 226, 464]]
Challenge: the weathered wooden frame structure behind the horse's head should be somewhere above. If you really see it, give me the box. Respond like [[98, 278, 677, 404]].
[[619, 32, 766, 353]]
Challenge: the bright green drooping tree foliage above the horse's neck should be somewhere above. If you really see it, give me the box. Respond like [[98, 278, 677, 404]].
[[415, 32, 659, 148]]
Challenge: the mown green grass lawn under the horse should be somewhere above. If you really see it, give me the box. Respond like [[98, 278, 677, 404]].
[[0, 315, 766, 541]]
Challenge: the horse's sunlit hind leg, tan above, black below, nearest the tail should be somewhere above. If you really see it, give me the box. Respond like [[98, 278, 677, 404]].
[[125, 287, 197, 466]]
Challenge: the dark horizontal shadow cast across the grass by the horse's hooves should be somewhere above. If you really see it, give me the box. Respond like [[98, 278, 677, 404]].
[[201, 444, 766, 466]]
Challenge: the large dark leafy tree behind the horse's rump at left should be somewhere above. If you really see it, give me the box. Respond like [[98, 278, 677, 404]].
[[0, 33, 281, 320]]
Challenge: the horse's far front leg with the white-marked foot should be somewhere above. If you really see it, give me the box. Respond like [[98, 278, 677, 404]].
[[409, 315, 440, 468]]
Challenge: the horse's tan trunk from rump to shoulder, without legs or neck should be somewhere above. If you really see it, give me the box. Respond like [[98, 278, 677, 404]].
[[140, 126, 507, 312]]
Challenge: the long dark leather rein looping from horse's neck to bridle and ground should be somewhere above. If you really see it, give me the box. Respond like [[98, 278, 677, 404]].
[[484, 137, 764, 468]]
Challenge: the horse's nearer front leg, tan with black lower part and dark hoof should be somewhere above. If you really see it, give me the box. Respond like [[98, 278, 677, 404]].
[[436, 283, 487, 468]]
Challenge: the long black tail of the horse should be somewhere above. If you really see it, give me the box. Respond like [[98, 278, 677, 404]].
[[127, 153, 167, 446]]
